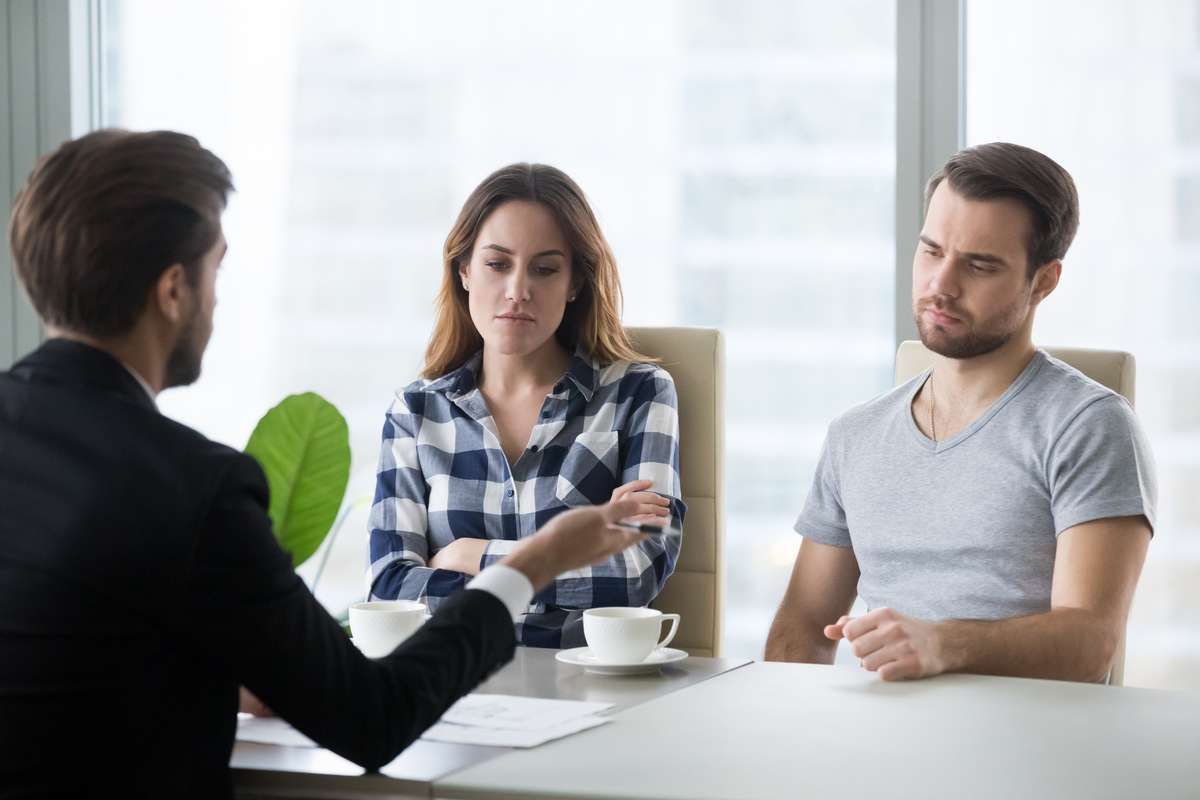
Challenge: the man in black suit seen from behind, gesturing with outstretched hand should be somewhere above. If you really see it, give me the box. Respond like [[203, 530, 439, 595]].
[[0, 131, 640, 798]]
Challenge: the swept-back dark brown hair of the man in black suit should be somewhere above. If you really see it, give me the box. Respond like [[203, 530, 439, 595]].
[[10, 130, 233, 338]]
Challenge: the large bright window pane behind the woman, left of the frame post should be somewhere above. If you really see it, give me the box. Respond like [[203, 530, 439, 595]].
[[103, 0, 895, 656]]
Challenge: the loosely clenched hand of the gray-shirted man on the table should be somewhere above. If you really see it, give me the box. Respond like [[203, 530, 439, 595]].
[[824, 608, 946, 680]]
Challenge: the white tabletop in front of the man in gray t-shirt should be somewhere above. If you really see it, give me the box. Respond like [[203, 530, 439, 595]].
[[433, 663, 1200, 800]]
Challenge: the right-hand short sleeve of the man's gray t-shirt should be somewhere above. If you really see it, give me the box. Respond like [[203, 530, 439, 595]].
[[1046, 395, 1158, 536]]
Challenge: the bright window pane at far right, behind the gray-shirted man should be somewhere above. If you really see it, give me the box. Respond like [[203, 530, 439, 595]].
[[966, 0, 1200, 688]]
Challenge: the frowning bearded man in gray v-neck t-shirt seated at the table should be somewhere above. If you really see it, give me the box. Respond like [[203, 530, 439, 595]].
[[767, 144, 1157, 680]]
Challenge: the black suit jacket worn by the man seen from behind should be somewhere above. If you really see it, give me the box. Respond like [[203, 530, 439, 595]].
[[0, 339, 515, 798]]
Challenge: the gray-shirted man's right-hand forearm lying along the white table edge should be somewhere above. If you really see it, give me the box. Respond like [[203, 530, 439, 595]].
[[937, 608, 1121, 682]]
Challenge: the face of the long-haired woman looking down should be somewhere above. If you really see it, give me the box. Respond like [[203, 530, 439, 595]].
[[458, 200, 574, 355]]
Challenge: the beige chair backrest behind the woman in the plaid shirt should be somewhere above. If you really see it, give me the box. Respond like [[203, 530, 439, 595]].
[[626, 327, 725, 656]]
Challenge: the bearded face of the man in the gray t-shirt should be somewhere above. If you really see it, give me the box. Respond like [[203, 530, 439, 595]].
[[912, 180, 1037, 359]]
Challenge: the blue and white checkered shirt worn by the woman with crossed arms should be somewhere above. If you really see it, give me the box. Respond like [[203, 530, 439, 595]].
[[370, 353, 685, 648]]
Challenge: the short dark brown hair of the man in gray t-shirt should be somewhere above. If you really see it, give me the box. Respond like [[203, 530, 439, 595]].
[[925, 142, 1079, 279]]
